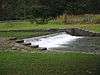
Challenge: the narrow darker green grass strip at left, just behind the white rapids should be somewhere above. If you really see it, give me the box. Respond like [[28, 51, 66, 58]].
[[0, 31, 50, 39]]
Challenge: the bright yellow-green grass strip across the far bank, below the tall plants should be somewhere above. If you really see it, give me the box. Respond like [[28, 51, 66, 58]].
[[0, 22, 100, 32]]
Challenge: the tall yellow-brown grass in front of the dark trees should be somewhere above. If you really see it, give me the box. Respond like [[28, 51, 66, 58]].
[[57, 14, 100, 24]]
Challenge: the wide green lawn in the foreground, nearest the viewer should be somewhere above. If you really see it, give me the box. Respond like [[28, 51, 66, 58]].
[[0, 52, 99, 75]]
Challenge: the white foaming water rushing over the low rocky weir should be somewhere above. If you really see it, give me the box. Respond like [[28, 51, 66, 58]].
[[24, 32, 81, 49]]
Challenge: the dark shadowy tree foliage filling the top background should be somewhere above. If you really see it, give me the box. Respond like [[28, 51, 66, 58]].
[[0, 0, 100, 22]]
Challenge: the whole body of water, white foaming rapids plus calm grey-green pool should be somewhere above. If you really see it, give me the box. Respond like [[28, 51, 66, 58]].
[[24, 32, 100, 53]]
